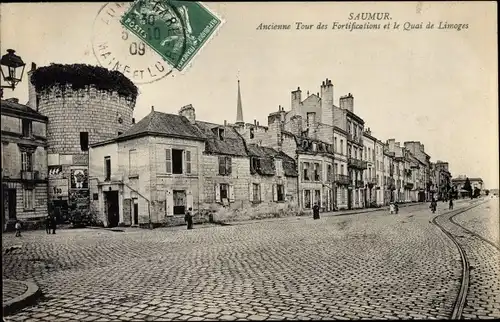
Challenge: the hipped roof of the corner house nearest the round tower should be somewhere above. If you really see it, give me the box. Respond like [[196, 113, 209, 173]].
[[118, 111, 205, 141]]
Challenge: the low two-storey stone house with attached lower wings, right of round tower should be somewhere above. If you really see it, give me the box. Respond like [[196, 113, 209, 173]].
[[90, 105, 297, 226]]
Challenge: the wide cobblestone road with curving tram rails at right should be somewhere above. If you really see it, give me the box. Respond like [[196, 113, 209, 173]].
[[2, 199, 500, 321]]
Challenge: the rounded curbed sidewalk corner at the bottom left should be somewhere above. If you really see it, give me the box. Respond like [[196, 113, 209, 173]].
[[2, 280, 42, 316]]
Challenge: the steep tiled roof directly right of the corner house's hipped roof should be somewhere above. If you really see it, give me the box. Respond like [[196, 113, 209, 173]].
[[196, 121, 247, 156]]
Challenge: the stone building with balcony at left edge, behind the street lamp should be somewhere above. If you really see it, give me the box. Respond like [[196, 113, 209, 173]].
[[1, 98, 48, 229]]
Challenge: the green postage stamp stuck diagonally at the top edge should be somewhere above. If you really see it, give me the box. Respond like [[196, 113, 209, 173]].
[[120, 0, 223, 72]]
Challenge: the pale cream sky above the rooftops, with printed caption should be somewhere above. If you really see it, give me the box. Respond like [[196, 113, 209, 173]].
[[0, 2, 499, 188]]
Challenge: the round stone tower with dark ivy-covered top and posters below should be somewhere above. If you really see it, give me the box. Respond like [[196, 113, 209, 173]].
[[28, 64, 137, 220]]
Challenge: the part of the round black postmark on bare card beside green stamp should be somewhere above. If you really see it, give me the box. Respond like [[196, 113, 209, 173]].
[[92, 2, 173, 85]]
